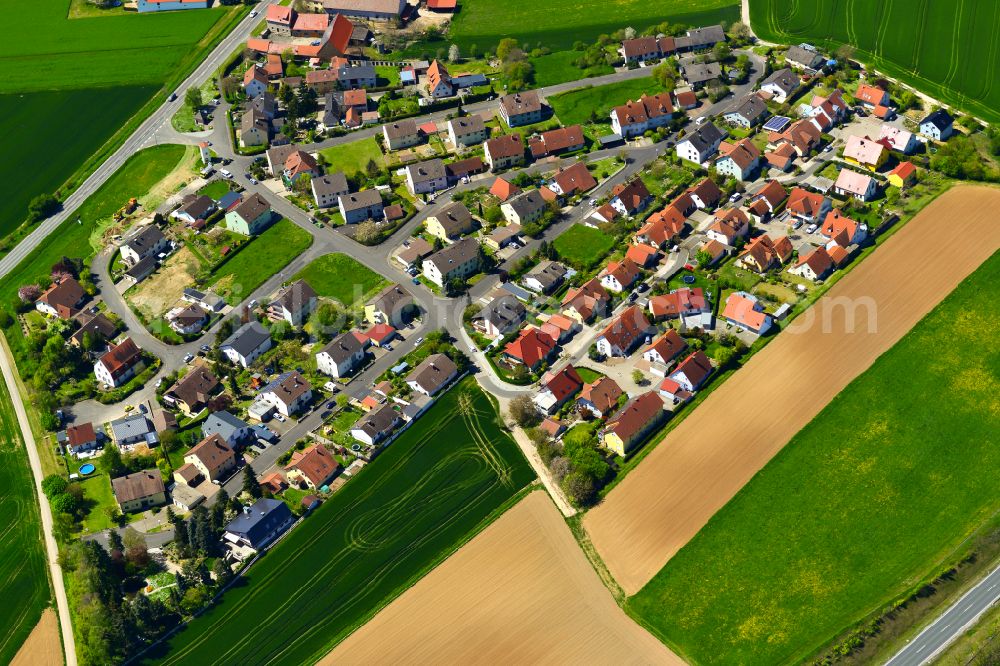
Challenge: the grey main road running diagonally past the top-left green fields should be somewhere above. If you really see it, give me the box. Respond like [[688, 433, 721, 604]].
[[0, 0, 277, 278]]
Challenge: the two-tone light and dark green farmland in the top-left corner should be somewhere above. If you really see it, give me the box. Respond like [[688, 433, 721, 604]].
[[0, 0, 249, 237]]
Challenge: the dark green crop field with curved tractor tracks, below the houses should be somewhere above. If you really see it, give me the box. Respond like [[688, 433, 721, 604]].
[[148, 379, 533, 666]]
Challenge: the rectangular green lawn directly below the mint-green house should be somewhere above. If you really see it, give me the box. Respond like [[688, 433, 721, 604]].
[[206, 218, 312, 303]]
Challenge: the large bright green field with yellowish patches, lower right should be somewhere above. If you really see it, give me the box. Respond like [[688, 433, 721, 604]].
[[626, 253, 1000, 664]]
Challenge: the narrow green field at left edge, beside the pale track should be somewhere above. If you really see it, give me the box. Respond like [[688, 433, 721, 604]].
[[0, 378, 51, 664]]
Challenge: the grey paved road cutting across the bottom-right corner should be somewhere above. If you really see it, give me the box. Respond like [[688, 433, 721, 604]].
[[886, 567, 1000, 666]]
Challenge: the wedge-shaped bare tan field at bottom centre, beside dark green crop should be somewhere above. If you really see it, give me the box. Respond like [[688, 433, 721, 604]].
[[320, 491, 684, 666]]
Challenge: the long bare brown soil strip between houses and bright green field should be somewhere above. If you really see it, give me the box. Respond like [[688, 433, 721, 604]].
[[584, 187, 1000, 595]]
